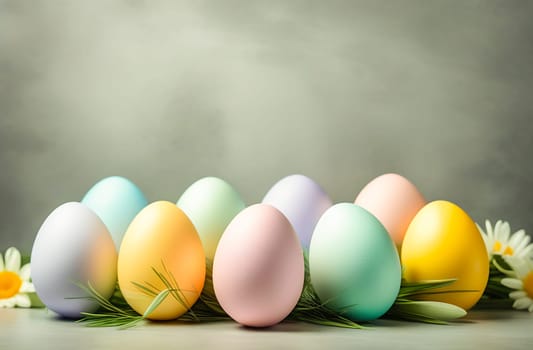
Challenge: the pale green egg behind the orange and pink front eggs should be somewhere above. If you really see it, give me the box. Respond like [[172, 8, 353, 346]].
[[177, 177, 245, 263]]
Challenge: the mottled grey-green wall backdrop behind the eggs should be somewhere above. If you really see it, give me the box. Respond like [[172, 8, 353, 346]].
[[0, 0, 533, 252]]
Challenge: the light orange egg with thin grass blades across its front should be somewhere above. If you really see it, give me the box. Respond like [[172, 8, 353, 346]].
[[118, 201, 205, 320]]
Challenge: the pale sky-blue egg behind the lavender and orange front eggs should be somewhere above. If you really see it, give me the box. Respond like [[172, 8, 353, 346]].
[[81, 176, 148, 249]]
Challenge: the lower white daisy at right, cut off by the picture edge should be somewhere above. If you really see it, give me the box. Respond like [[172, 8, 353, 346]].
[[501, 257, 533, 312]]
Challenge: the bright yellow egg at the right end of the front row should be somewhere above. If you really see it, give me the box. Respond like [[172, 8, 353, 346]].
[[401, 201, 489, 310]]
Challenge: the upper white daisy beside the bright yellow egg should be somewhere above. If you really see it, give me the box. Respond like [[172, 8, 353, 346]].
[[476, 220, 533, 259]]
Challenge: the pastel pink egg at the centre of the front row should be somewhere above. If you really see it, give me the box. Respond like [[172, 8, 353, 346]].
[[213, 204, 305, 327]]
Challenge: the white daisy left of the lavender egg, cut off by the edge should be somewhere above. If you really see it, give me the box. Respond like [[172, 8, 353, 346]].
[[0, 247, 35, 308]]
